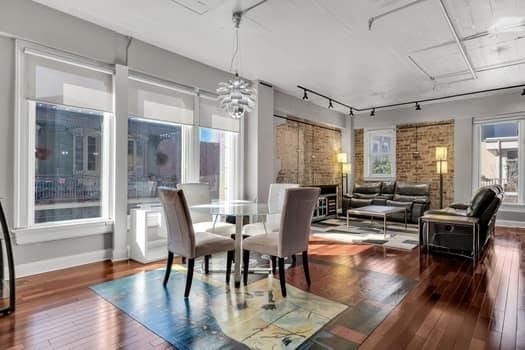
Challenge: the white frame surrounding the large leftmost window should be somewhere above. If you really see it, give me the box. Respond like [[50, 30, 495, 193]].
[[14, 40, 114, 244]]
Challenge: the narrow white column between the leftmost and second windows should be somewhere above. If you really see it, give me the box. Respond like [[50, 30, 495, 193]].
[[112, 64, 128, 261]]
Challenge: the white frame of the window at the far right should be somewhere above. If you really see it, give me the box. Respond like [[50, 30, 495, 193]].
[[472, 113, 525, 206]]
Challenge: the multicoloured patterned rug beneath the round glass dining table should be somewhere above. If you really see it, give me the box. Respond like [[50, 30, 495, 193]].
[[91, 258, 415, 349]]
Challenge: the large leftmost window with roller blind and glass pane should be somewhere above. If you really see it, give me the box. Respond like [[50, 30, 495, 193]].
[[17, 48, 113, 227]]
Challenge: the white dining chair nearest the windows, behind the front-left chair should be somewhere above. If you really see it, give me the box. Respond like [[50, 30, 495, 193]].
[[177, 183, 235, 237]]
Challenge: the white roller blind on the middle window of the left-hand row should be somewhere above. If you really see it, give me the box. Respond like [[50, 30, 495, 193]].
[[128, 77, 195, 125]]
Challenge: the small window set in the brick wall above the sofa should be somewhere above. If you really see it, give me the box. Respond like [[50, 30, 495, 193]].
[[364, 128, 396, 179]]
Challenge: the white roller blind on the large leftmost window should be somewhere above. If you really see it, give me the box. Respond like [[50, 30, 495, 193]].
[[24, 50, 113, 112]]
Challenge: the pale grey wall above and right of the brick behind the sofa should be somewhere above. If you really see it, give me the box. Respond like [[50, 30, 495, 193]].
[[355, 89, 525, 221]]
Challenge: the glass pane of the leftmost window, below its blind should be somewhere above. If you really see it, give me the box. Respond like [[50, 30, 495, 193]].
[[34, 103, 104, 223]]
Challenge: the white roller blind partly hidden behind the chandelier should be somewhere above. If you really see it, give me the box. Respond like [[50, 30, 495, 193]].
[[199, 94, 241, 132]]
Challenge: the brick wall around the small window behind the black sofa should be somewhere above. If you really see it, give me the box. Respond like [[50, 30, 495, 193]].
[[354, 121, 454, 208]]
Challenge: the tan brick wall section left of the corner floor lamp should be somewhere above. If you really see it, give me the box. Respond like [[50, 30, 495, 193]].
[[275, 120, 341, 185]]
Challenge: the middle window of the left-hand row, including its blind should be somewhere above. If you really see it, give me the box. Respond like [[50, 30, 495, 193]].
[[128, 76, 195, 208]]
